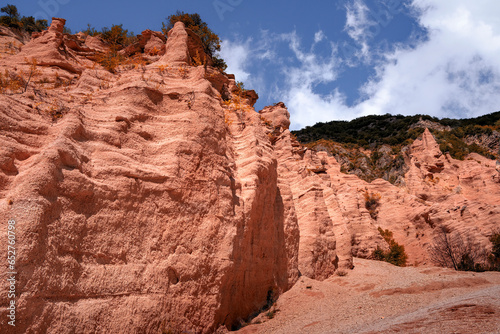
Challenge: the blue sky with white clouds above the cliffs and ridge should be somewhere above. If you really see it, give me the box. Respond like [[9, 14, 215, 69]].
[[5, 0, 500, 129]]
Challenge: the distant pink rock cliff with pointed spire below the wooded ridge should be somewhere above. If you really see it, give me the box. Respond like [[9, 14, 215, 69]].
[[320, 130, 500, 265]]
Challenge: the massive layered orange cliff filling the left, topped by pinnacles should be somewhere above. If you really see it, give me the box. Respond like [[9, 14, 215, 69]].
[[0, 19, 335, 333]]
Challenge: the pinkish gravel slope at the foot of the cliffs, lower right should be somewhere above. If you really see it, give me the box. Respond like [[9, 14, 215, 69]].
[[237, 259, 500, 334]]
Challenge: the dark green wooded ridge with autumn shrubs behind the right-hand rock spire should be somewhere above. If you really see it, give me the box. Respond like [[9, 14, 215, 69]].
[[293, 112, 500, 184]]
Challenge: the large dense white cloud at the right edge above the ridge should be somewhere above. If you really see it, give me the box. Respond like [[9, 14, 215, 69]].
[[356, 0, 500, 117]]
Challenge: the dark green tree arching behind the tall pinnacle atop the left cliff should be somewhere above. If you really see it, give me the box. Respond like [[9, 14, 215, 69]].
[[162, 11, 227, 71]]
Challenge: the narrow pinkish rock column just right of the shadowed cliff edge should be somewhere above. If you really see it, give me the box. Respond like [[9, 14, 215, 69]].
[[260, 103, 338, 279]]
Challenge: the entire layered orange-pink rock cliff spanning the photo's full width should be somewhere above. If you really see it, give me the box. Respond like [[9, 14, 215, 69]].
[[0, 19, 500, 333]]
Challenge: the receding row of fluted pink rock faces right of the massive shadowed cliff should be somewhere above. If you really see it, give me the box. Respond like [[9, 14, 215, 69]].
[[261, 112, 500, 268]]
